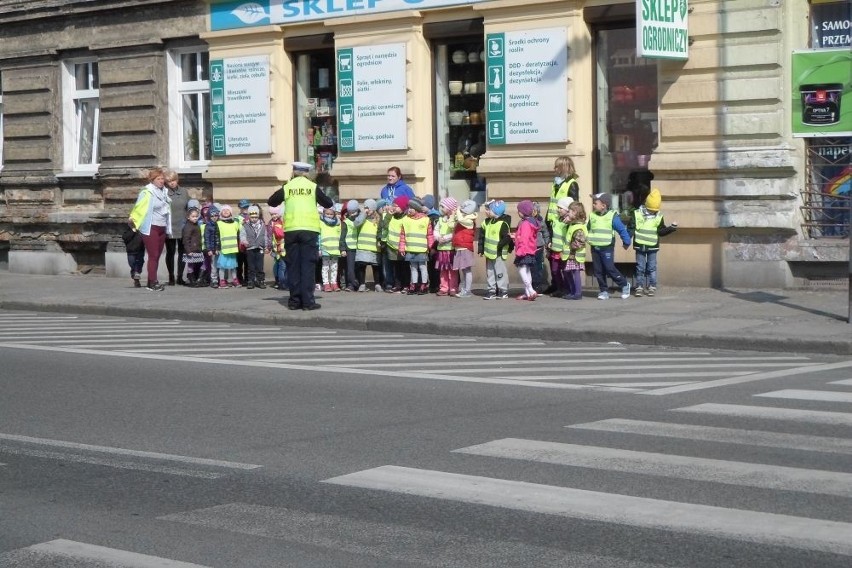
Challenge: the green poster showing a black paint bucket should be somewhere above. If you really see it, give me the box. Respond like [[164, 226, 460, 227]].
[[792, 49, 852, 138]]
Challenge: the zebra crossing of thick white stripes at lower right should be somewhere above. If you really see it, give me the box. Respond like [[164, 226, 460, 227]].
[[324, 379, 852, 566]]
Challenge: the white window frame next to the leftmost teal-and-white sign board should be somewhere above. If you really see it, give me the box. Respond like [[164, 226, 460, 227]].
[[167, 45, 212, 172]]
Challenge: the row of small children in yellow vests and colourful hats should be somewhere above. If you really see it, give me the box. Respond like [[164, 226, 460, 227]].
[[127, 182, 677, 301]]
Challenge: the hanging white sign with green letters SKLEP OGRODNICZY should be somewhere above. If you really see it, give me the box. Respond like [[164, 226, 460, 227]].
[[636, 0, 689, 60]]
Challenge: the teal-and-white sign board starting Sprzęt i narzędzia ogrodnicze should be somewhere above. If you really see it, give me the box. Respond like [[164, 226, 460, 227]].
[[337, 43, 408, 152]]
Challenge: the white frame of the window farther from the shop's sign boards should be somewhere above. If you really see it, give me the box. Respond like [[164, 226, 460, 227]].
[[62, 57, 101, 172]]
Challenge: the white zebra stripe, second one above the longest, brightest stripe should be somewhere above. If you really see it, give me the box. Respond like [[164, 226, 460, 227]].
[[566, 418, 852, 454]]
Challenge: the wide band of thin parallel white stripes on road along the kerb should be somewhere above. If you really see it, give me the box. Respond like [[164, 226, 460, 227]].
[[0, 311, 840, 395]]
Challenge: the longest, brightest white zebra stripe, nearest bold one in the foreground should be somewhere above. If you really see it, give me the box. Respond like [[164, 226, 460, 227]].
[[325, 466, 852, 555]]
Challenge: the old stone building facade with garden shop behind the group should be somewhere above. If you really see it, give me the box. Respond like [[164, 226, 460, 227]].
[[0, 0, 852, 288]]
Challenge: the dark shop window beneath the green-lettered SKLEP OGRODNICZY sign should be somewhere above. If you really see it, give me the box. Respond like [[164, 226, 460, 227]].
[[595, 27, 658, 214]]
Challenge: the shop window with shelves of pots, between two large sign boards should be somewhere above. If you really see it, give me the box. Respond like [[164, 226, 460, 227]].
[[435, 41, 487, 203]]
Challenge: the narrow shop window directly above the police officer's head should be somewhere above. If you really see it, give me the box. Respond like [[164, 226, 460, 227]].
[[296, 49, 338, 176]]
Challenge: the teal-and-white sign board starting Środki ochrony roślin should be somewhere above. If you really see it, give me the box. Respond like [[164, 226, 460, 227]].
[[485, 27, 568, 144]]
